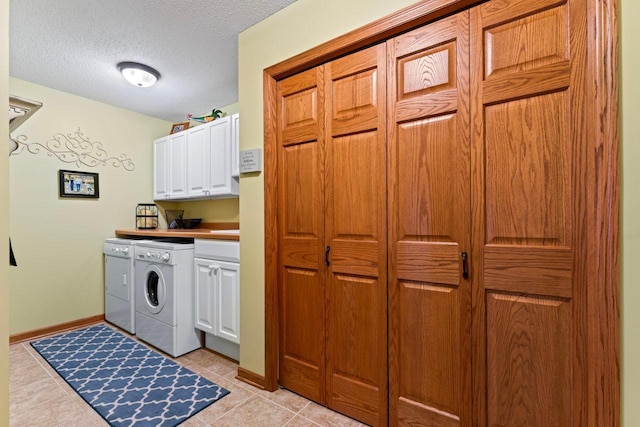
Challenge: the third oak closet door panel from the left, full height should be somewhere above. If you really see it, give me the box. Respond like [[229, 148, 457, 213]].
[[387, 12, 471, 426]]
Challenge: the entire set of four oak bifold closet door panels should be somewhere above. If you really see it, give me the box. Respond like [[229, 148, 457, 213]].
[[275, 0, 604, 427]]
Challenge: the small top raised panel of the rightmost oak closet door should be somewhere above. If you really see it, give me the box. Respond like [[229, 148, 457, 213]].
[[484, 5, 569, 78]]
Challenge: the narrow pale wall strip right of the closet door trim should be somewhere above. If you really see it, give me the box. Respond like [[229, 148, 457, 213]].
[[618, 0, 640, 427]]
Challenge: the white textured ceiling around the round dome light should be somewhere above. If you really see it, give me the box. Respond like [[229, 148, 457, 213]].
[[9, 0, 295, 122]]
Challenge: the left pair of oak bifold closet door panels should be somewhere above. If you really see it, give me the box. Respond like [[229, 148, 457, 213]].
[[277, 44, 388, 425]]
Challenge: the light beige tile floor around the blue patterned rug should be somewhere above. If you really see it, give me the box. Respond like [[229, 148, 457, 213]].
[[9, 326, 363, 427]]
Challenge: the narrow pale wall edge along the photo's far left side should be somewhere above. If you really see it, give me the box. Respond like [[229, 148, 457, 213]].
[[0, 0, 9, 427]]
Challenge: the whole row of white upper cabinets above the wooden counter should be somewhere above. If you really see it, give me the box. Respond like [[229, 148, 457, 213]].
[[154, 114, 239, 200]]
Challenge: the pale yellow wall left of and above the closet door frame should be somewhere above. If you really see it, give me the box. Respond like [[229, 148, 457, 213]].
[[238, 0, 416, 375]]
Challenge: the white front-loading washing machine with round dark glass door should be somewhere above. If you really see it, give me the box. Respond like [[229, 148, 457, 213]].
[[135, 241, 200, 357]]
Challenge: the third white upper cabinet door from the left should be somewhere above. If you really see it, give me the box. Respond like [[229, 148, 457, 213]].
[[187, 125, 211, 197]]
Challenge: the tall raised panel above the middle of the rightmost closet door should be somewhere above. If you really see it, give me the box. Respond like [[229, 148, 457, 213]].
[[485, 92, 571, 246]]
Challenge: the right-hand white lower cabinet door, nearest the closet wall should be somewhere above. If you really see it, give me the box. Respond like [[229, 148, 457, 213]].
[[213, 261, 240, 344]]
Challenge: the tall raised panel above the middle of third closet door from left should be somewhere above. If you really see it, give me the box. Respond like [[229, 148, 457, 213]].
[[396, 114, 458, 241]]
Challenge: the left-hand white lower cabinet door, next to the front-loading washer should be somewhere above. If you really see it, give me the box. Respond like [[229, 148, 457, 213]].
[[194, 258, 217, 334]]
